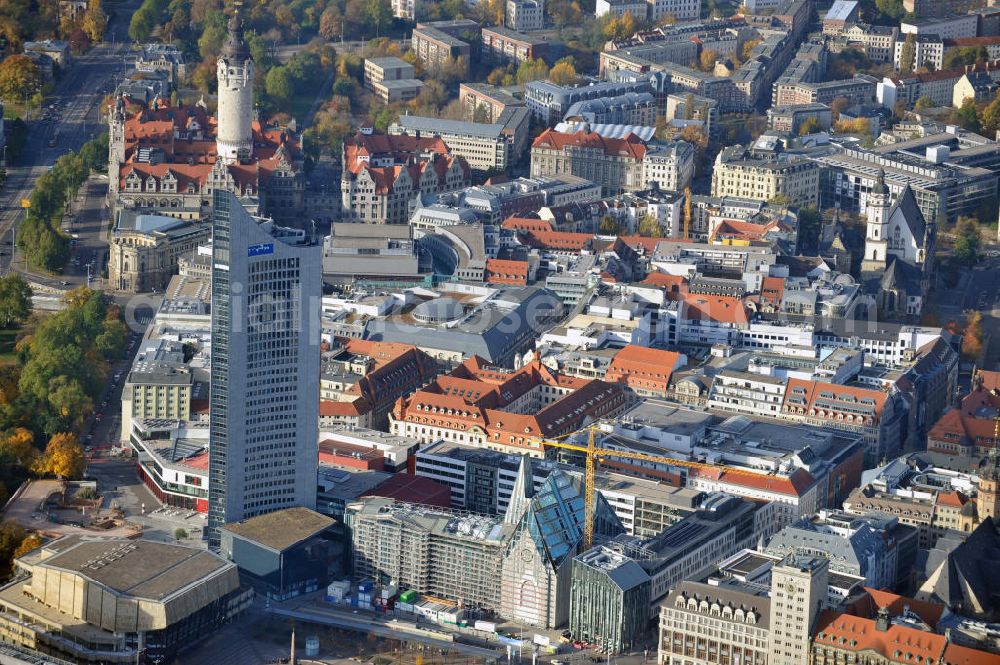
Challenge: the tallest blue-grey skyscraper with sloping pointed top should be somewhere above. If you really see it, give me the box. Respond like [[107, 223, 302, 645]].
[[208, 189, 321, 548]]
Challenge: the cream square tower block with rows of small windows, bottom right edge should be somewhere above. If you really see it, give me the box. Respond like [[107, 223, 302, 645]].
[[768, 554, 830, 665]]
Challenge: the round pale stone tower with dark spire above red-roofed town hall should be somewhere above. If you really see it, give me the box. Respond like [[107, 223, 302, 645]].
[[216, 7, 254, 164]]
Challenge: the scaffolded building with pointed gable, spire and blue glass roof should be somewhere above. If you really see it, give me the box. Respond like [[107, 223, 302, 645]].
[[345, 463, 624, 628]]
